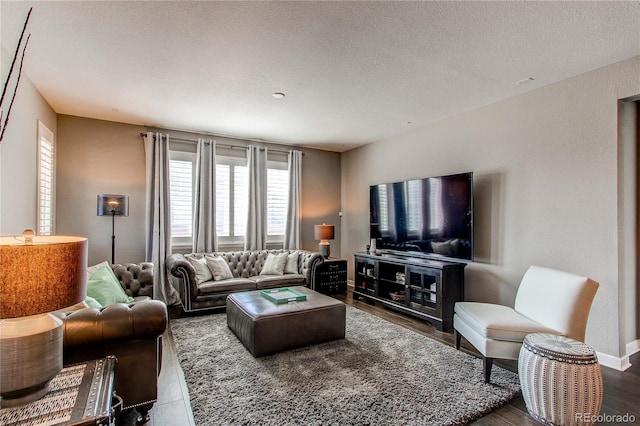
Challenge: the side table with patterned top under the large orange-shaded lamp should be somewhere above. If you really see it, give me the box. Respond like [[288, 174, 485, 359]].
[[0, 356, 116, 426]]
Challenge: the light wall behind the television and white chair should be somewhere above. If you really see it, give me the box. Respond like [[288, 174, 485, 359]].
[[342, 57, 640, 357]]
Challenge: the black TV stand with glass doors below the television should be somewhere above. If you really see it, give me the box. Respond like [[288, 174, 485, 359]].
[[353, 253, 466, 331]]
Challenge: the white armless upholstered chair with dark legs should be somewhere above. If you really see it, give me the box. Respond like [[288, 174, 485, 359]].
[[453, 266, 599, 383]]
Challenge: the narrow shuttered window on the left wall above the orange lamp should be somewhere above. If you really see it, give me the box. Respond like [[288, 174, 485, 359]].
[[37, 121, 55, 235]]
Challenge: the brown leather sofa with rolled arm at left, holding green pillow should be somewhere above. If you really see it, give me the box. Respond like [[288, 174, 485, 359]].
[[61, 263, 167, 423]]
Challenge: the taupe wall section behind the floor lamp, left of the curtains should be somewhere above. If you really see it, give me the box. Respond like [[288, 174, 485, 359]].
[[56, 115, 146, 265]]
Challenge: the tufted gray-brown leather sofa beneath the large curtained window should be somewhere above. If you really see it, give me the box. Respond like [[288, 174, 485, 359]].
[[166, 250, 324, 312]]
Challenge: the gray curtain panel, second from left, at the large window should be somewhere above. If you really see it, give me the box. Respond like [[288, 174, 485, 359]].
[[193, 139, 218, 253]]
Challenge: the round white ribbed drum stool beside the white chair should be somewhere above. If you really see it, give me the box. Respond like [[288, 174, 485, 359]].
[[518, 333, 603, 425]]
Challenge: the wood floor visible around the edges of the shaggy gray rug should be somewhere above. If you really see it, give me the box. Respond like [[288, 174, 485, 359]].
[[131, 291, 640, 426]]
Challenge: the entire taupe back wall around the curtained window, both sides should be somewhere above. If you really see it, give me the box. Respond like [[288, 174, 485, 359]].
[[56, 115, 341, 265]]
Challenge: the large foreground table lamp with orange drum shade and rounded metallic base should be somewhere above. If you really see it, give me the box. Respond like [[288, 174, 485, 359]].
[[0, 230, 87, 408]]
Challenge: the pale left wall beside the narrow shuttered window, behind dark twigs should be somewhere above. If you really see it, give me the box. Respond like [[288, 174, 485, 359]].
[[0, 49, 56, 235]]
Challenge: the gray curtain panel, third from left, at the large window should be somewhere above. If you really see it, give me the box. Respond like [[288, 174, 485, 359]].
[[244, 145, 267, 250]]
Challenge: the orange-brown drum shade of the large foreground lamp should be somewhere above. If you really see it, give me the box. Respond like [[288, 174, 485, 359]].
[[0, 233, 87, 319]]
